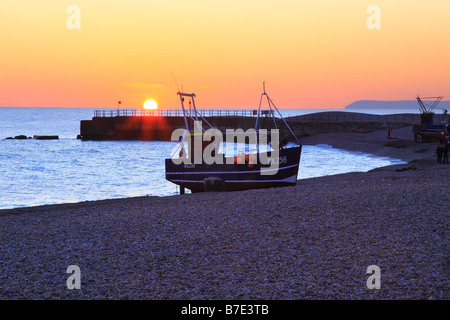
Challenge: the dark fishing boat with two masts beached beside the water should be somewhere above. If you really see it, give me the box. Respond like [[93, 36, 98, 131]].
[[165, 88, 302, 194]]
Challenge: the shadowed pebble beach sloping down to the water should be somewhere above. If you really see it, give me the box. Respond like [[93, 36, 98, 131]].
[[0, 128, 450, 300]]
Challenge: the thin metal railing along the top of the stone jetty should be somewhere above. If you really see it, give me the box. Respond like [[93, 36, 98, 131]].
[[94, 109, 264, 117]]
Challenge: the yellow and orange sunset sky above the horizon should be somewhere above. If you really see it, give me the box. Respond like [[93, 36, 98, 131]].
[[0, 0, 450, 108]]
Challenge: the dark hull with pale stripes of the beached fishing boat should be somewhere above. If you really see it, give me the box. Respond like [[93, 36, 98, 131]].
[[165, 145, 302, 192]]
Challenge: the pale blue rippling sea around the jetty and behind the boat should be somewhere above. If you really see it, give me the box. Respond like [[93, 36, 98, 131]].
[[0, 107, 417, 209]]
